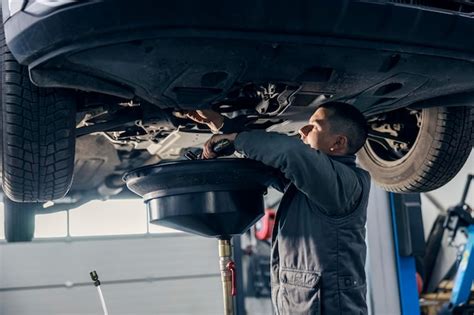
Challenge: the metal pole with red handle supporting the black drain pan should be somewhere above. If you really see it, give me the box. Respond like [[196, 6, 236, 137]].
[[219, 239, 235, 315]]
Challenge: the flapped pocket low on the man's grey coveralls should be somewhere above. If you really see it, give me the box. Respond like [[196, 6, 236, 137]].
[[277, 268, 321, 315]]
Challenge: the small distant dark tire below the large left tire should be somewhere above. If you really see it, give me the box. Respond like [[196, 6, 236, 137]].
[[3, 197, 35, 243]]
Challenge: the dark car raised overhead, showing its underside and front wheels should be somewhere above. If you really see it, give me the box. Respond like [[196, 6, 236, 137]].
[[1, 0, 474, 242]]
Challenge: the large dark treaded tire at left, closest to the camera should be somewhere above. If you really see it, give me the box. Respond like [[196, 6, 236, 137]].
[[0, 27, 76, 202]]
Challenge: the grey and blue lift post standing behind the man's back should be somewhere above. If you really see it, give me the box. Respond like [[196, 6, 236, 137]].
[[366, 184, 425, 315]]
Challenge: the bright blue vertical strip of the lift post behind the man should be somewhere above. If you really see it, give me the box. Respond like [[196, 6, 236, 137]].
[[389, 193, 420, 315]]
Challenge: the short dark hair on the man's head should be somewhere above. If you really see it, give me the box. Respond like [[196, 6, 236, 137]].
[[319, 102, 368, 154]]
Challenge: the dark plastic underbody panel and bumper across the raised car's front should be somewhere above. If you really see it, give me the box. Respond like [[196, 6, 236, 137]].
[[5, 1, 474, 115]]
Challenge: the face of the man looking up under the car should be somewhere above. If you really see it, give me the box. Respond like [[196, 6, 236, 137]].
[[299, 108, 338, 154]]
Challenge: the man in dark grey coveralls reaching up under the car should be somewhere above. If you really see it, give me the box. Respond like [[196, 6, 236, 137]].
[[187, 102, 370, 315]]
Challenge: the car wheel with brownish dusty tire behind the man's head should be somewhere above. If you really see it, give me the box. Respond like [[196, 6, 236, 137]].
[[358, 107, 474, 193]]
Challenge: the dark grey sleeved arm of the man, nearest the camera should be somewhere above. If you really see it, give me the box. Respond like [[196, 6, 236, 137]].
[[234, 131, 362, 216]]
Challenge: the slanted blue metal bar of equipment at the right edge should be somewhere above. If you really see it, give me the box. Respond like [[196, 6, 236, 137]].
[[451, 225, 474, 306]]
